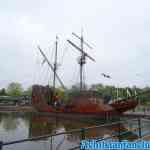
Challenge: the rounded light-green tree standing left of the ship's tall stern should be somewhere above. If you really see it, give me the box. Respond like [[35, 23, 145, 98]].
[[7, 82, 23, 96]]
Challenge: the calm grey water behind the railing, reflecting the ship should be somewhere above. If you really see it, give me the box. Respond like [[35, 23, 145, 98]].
[[0, 113, 150, 150]]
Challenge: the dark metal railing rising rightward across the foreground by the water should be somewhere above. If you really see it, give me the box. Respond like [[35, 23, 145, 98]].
[[0, 117, 150, 150]]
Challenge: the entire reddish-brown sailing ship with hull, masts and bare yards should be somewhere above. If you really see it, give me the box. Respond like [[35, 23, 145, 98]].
[[32, 33, 138, 118]]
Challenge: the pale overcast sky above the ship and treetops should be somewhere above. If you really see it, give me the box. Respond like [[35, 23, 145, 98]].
[[0, 0, 150, 88]]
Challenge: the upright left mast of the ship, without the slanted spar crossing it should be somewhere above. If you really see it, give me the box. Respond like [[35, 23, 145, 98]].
[[53, 36, 58, 94]]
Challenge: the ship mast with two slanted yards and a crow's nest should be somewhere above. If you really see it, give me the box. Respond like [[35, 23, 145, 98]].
[[67, 33, 95, 91]]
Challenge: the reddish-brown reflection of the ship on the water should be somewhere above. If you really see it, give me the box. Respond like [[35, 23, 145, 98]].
[[30, 116, 138, 143]]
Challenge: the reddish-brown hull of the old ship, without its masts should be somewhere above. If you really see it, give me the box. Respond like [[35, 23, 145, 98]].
[[32, 85, 137, 116]]
